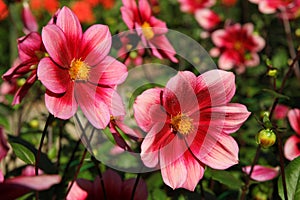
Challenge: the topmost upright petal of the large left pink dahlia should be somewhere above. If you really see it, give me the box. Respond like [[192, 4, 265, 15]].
[[56, 6, 82, 57]]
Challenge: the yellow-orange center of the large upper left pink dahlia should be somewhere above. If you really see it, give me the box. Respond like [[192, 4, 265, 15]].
[[69, 59, 91, 81]]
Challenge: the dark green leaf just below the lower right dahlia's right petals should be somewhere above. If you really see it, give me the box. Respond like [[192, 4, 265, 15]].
[[210, 170, 242, 189]]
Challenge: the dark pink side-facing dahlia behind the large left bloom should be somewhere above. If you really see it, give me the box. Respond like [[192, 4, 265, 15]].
[[2, 32, 47, 105]]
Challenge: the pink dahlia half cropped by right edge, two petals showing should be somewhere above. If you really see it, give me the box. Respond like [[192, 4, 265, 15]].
[[284, 109, 300, 160]]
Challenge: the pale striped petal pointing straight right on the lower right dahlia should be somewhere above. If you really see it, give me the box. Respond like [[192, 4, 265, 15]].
[[199, 103, 250, 134]]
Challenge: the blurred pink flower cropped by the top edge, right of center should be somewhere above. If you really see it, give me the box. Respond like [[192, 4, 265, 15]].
[[178, 0, 216, 14]]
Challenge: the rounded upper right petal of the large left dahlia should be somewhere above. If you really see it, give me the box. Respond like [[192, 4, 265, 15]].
[[80, 24, 111, 66]]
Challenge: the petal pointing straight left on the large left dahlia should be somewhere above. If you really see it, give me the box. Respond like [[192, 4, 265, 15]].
[[37, 57, 71, 94]]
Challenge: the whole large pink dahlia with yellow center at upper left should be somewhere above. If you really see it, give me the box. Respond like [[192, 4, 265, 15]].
[[37, 7, 127, 128]]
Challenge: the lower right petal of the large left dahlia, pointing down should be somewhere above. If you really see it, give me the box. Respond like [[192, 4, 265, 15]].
[[75, 83, 111, 129]]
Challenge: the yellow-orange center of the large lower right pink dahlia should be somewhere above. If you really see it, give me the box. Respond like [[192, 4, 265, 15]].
[[171, 113, 194, 135]]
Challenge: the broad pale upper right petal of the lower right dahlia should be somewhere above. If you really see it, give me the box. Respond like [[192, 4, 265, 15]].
[[195, 70, 236, 110]]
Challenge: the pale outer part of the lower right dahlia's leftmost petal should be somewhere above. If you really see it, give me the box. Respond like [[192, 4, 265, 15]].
[[133, 88, 162, 132]]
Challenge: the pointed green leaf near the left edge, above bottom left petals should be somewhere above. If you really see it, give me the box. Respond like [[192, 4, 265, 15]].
[[10, 142, 35, 165]]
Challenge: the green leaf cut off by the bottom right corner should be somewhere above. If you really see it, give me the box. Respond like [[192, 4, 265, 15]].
[[278, 157, 300, 200]]
